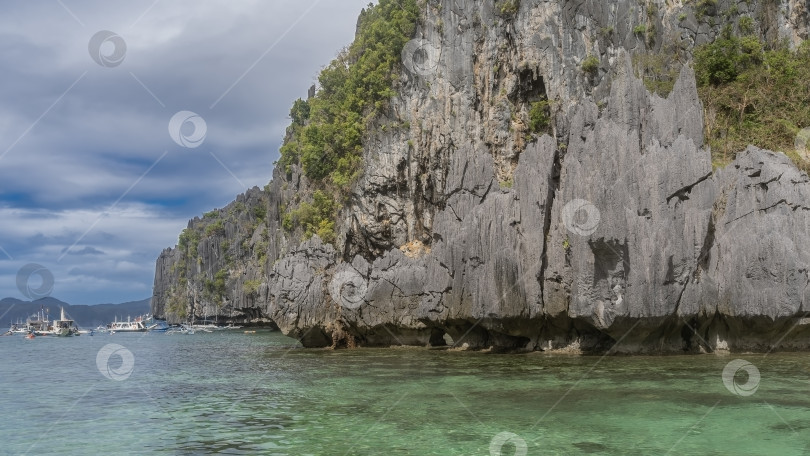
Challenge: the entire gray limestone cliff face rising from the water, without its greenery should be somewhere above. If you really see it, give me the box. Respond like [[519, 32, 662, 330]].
[[152, 0, 810, 352]]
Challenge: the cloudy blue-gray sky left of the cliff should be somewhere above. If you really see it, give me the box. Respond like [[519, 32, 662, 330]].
[[0, 0, 368, 304]]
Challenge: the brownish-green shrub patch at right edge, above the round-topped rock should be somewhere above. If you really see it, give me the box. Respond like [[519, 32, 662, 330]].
[[695, 35, 810, 169]]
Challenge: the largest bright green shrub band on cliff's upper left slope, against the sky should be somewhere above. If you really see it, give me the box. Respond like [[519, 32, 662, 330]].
[[279, 0, 419, 187]]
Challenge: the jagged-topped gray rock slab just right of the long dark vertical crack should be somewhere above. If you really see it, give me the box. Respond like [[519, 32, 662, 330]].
[[544, 56, 714, 350]]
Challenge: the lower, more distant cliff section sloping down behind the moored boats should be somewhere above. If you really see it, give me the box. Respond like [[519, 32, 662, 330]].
[[152, 185, 285, 322]]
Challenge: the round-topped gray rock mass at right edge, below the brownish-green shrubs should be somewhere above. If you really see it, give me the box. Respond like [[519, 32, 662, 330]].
[[679, 147, 810, 351]]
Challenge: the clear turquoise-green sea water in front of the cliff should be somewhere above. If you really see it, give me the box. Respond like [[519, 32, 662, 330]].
[[0, 331, 810, 455]]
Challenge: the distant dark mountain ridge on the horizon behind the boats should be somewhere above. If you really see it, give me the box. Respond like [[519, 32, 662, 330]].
[[0, 297, 151, 331]]
